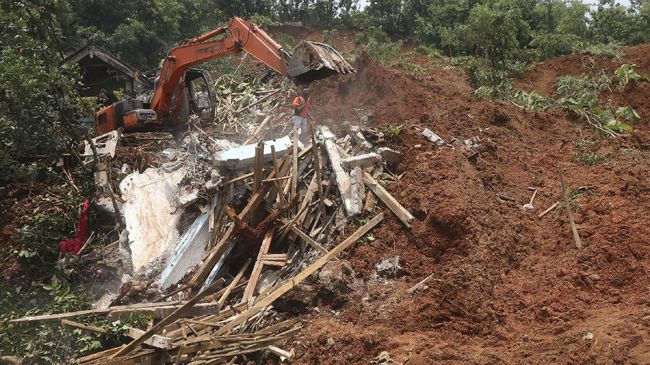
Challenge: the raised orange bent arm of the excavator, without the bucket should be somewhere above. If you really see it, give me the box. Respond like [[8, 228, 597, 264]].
[[151, 17, 289, 118]]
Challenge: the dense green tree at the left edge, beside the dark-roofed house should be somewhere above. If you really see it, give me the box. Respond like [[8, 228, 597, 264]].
[[0, 0, 90, 183]]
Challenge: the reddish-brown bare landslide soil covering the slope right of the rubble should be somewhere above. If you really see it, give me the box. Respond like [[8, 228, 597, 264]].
[[294, 45, 650, 364]]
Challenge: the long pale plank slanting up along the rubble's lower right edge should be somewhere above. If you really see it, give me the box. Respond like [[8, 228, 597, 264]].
[[214, 213, 384, 336]]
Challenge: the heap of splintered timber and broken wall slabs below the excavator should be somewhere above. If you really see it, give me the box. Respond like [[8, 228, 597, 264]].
[[14, 77, 413, 364]]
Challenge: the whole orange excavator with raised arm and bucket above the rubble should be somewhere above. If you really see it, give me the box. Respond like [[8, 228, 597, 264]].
[[95, 17, 355, 134]]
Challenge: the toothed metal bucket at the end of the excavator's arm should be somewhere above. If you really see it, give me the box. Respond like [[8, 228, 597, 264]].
[[288, 41, 356, 82]]
